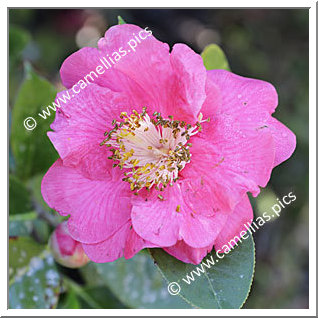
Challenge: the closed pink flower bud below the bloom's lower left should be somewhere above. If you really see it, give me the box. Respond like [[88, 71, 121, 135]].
[[49, 221, 89, 268]]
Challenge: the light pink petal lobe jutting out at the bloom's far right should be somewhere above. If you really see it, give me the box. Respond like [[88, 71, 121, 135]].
[[267, 117, 296, 166]]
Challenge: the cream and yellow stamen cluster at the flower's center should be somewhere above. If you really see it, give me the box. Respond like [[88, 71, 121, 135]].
[[101, 108, 209, 194]]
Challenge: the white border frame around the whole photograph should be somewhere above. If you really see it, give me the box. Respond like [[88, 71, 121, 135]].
[[0, 0, 317, 317]]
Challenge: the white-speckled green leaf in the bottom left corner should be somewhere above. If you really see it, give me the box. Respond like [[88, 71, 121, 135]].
[[9, 237, 61, 309]]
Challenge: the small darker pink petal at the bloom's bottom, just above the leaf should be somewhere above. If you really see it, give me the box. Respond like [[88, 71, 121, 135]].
[[164, 240, 213, 265]]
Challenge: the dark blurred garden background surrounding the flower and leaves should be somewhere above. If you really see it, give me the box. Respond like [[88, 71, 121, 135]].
[[9, 9, 309, 308]]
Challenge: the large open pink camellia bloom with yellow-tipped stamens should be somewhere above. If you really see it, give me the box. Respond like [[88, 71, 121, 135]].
[[42, 24, 296, 264]]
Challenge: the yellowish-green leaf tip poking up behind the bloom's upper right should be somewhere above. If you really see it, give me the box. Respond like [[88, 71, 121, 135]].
[[201, 44, 230, 71]]
